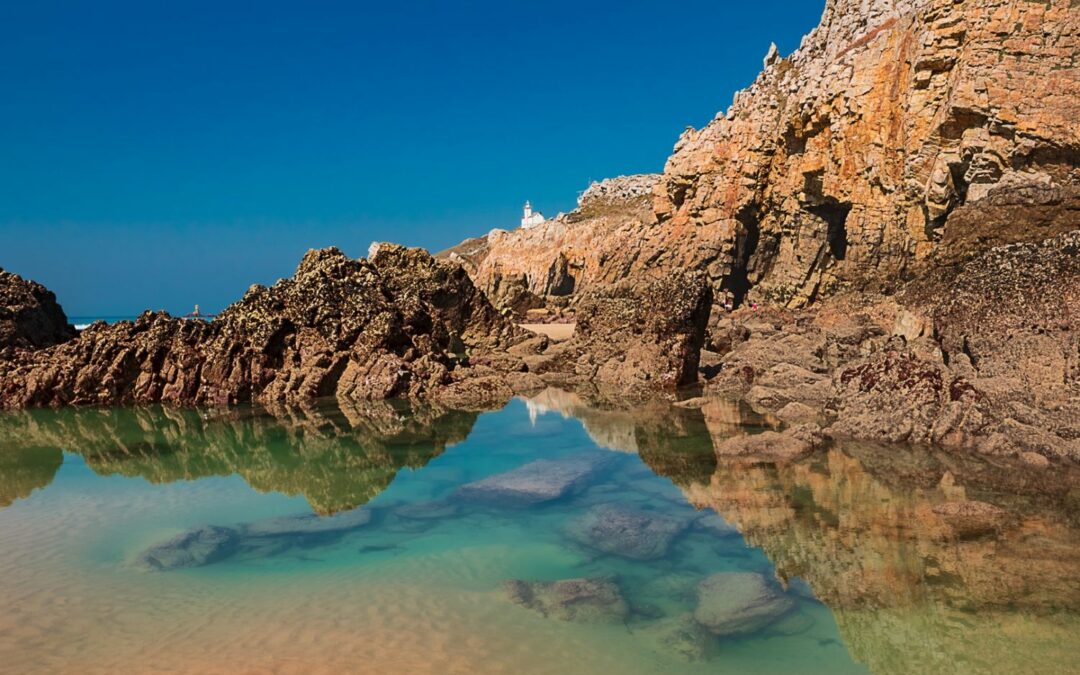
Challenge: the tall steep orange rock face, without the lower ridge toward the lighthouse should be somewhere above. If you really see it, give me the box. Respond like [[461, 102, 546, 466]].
[[656, 0, 1080, 305]]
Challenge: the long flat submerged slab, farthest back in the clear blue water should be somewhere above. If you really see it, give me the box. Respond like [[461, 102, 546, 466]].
[[457, 454, 608, 507]]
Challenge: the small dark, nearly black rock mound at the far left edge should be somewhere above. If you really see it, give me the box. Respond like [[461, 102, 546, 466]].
[[0, 269, 76, 359]]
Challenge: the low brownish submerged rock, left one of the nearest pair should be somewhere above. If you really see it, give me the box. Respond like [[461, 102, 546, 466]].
[[502, 579, 630, 623]]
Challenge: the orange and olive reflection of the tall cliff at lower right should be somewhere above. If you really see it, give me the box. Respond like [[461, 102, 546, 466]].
[[685, 445, 1080, 673]]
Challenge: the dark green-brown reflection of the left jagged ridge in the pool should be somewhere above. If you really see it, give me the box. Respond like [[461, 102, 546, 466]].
[[0, 403, 476, 513]]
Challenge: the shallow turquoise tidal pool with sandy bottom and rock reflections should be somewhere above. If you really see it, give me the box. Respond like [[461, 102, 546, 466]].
[[0, 393, 1080, 673]]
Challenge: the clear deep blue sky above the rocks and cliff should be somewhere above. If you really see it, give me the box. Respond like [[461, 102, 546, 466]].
[[0, 0, 824, 315]]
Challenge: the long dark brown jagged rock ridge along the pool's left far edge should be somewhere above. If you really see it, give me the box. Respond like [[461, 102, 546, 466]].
[[0, 244, 528, 407]]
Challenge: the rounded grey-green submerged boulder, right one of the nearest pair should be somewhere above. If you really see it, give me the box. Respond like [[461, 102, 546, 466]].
[[693, 572, 795, 635]]
